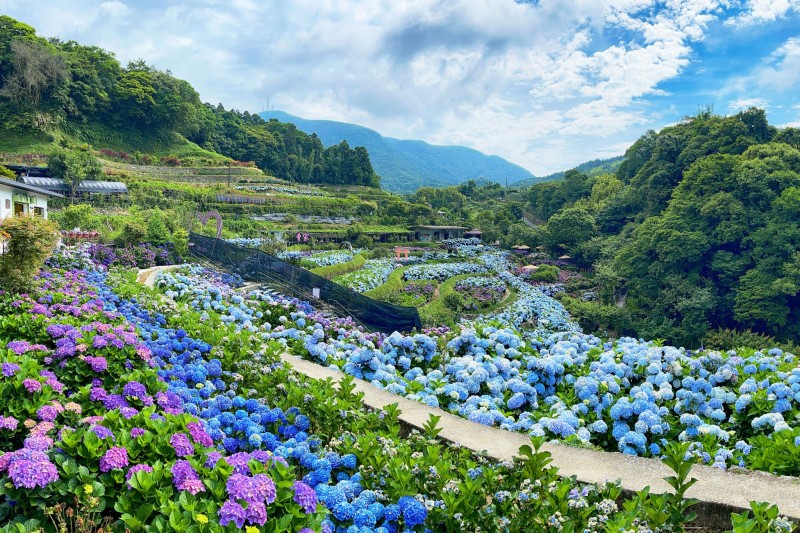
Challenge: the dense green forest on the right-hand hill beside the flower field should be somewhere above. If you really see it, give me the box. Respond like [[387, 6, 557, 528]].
[[528, 108, 800, 346]]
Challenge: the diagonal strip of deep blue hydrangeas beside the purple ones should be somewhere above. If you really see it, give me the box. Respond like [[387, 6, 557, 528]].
[[89, 269, 427, 533]]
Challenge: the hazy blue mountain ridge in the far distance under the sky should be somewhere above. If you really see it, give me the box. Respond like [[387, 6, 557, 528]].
[[259, 111, 539, 193]]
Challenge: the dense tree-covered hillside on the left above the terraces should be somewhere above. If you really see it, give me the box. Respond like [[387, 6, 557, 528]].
[[0, 16, 379, 187]]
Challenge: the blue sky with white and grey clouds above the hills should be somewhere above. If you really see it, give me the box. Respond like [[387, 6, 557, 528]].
[[0, 0, 800, 175]]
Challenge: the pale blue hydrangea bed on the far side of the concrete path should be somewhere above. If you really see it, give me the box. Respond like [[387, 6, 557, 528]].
[[152, 247, 800, 475]]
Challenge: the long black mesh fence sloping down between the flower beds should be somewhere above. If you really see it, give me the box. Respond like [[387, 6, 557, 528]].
[[189, 233, 422, 333]]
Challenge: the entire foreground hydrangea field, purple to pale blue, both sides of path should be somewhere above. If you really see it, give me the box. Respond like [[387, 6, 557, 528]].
[[0, 243, 798, 533]]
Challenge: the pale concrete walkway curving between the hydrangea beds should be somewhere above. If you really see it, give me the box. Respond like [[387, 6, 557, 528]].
[[137, 267, 800, 526]]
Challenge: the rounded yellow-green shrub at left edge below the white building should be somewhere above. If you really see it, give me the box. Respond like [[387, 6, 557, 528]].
[[0, 217, 58, 292]]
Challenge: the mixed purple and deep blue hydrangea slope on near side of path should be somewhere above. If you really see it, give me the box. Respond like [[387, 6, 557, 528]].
[[0, 250, 776, 533]]
